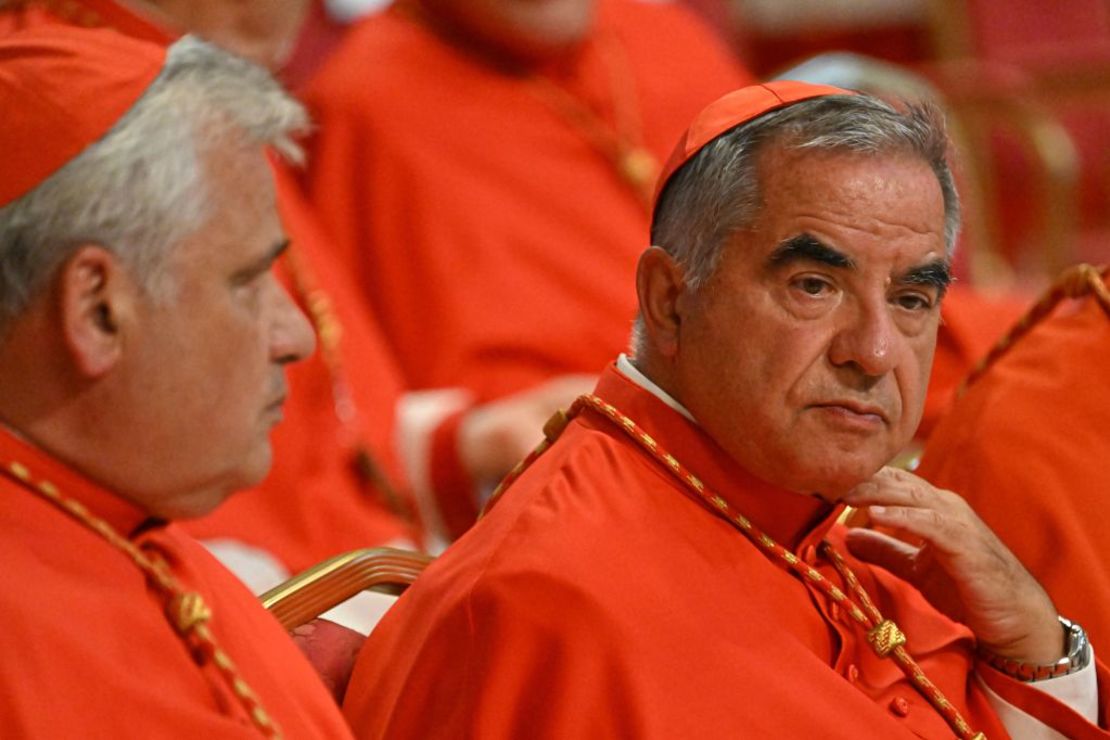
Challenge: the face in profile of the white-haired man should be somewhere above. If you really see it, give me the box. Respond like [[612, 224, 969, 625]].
[[127, 144, 314, 517]]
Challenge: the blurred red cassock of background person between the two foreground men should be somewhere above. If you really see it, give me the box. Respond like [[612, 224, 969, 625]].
[[304, 0, 750, 401]]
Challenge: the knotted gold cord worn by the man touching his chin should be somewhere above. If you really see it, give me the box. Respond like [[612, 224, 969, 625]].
[[483, 394, 986, 740]]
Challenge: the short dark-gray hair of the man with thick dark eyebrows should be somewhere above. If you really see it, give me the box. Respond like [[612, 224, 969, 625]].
[[632, 94, 960, 354]]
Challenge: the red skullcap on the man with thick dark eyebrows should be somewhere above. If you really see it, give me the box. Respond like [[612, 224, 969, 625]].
[[655, 80, 856, 205]]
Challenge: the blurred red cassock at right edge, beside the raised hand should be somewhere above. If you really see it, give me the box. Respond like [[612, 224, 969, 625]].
[[918, 269, 1110, 656]]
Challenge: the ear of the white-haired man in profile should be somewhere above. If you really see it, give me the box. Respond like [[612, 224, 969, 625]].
[[58, 244, 132, 378]]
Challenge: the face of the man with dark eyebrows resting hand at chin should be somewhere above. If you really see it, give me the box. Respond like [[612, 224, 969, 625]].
[[676, 146, 947, 498]]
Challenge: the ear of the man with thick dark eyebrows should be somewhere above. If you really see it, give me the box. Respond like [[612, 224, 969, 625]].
[[636, 246, 686, 357]]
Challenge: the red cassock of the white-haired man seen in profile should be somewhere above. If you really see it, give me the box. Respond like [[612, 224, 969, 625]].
[[0, 429, 350, 740]]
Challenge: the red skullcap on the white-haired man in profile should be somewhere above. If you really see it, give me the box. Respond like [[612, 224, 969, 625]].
[[0, 26, 165, 207]]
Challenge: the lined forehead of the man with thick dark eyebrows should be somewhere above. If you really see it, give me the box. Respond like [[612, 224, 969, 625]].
[[753, 145, 945, 269]]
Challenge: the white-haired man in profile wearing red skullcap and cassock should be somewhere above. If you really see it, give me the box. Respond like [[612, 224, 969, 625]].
[[0, 28, 347, 738]]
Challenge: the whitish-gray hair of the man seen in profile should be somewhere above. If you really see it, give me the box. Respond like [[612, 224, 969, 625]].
[[0, 37, 307, 332]]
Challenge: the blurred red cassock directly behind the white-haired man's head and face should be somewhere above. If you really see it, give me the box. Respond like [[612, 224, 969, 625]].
[[0, 0, 415, 571]]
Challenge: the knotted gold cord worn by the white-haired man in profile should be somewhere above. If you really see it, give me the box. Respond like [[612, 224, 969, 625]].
[[3, 462, 282, 739]]
